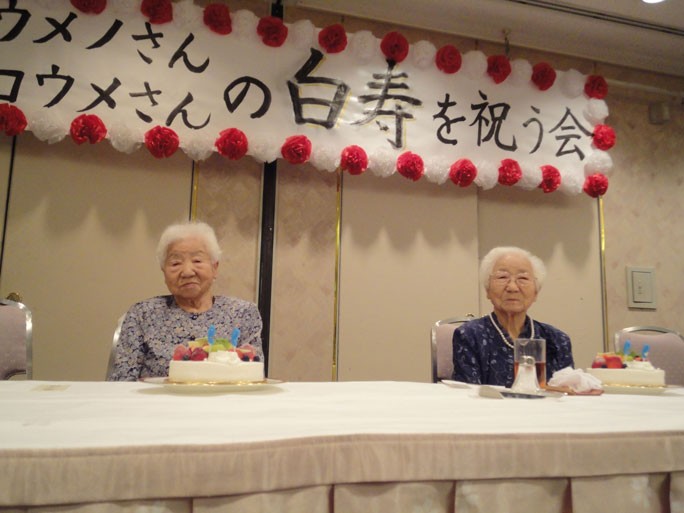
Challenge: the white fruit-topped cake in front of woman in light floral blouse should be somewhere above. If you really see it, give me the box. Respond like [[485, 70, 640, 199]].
[[169, 339, 264, 384]]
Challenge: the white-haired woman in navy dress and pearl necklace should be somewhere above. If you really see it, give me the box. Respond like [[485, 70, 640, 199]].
[[453, 246, 574, 387]]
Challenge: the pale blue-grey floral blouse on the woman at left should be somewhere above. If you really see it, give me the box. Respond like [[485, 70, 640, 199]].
[[107, 295, 264, 381]]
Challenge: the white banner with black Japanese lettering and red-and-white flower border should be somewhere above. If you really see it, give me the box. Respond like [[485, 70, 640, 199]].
[[0, 0, 615, 196]]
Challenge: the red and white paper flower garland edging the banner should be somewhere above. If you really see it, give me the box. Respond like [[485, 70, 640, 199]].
[[0, 0, 616, 198]]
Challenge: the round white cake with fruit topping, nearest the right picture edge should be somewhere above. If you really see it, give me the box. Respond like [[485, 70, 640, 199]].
[[587, 353, 665, 387]]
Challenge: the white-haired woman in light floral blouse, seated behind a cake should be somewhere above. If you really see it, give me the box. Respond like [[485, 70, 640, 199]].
[[108, 222, 264, 381]]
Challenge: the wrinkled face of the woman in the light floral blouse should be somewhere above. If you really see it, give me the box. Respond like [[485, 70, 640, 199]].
[[162, 237, 218, 300]]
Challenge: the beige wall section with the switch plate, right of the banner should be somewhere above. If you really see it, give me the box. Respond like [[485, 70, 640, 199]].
[[604, 85, 684, 334]]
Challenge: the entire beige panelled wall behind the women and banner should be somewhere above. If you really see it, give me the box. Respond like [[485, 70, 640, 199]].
[[0, 2, 684, 380]]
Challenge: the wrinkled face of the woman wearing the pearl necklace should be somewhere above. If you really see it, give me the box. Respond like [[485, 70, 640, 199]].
[[487, 255, 537, 314]]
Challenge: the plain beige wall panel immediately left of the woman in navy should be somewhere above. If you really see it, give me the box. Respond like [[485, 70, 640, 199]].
[[338, 173, 478, 381]]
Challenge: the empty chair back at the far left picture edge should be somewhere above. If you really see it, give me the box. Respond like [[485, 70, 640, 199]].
[[0, 299, 33, 380]]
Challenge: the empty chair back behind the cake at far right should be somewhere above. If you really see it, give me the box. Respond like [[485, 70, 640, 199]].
[[615, 326, 684, 386]]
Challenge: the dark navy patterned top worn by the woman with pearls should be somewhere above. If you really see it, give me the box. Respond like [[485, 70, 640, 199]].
[[453, 314, 574, 387]]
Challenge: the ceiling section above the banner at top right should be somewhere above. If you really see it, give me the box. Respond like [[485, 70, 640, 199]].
[[292, 0, 684, 77]]
